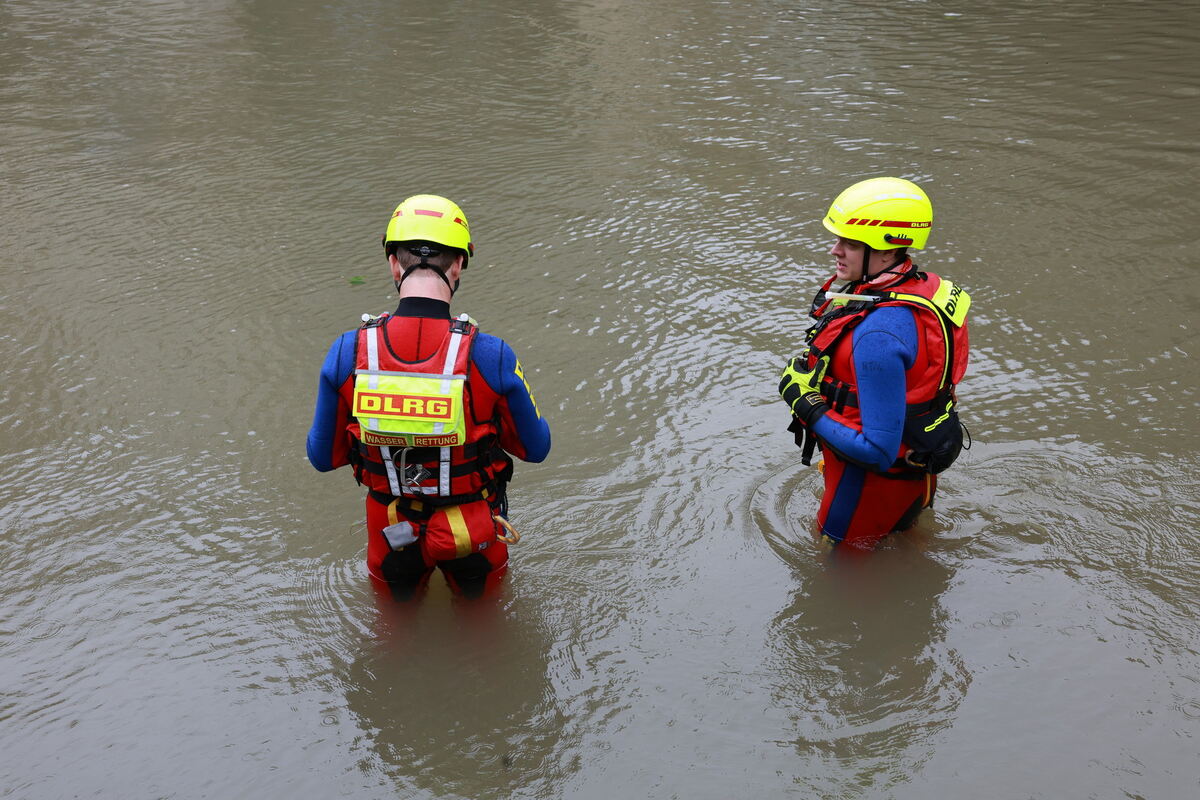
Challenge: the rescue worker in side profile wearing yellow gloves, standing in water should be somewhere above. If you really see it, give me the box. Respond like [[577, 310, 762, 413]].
[[779, 178, 971, 549]]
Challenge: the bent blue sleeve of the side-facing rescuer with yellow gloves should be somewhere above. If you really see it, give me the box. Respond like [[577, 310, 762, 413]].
[[812, 306, 917, 470]]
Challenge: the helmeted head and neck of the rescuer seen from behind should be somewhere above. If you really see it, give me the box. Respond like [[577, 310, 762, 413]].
[[383, 194, 475, 296]]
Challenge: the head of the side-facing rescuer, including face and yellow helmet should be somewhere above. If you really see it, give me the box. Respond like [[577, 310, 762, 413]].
[[822, 178, 934, 282]]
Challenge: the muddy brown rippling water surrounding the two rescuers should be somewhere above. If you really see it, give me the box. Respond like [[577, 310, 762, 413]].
[[0, 0, 1200, 799]]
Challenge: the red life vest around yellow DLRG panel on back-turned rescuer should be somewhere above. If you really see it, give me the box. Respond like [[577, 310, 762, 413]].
[[347, 314, 512, 512]]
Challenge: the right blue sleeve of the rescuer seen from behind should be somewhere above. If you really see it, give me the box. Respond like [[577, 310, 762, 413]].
[[472, 333, 550, 462]]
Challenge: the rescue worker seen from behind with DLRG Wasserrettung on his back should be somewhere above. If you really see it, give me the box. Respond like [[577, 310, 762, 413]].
[[307, 194, 550, 600]]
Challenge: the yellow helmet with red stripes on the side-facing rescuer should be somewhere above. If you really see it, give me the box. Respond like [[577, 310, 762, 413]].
[[822, 178, 934, 249]]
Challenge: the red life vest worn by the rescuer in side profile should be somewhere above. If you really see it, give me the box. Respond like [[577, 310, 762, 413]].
[[806, 269, 971, 477]]
